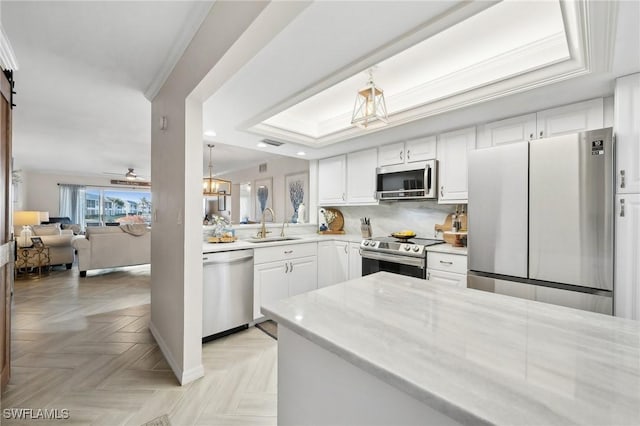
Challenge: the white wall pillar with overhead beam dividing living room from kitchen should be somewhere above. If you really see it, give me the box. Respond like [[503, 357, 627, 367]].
[[150, 1, 308, 384]]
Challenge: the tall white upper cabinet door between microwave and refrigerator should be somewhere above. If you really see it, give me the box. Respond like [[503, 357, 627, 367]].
[[438, 127, 476, 204]]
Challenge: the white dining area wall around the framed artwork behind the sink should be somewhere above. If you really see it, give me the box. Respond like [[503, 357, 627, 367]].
[[220, 157, 309, 222]]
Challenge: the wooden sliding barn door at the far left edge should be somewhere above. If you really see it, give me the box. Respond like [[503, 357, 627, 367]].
[[0, 73, 14, 391]]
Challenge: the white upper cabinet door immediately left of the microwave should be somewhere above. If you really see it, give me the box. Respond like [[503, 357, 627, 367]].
[[347, 148, 378, 204]]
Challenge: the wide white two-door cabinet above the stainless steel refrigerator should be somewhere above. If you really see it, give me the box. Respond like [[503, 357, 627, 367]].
[[477, 98, 605, 148]]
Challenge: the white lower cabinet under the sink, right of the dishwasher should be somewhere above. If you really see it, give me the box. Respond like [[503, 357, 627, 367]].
[[253, 243, 318, 319]]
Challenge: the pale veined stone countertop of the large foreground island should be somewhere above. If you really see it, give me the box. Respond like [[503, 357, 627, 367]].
[[262, 272, 640, 425]]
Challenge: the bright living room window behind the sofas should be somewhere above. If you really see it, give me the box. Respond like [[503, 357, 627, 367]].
[[84, 187, 151, 226]]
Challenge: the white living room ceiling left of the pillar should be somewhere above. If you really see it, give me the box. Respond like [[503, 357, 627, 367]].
[[0, 1, 211, 176]]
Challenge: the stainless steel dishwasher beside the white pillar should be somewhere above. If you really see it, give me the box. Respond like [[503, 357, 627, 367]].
[[202, 249, 253, 343]]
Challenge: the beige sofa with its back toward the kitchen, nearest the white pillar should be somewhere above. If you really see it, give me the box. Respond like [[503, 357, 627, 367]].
[[72, 224, 151, 277]]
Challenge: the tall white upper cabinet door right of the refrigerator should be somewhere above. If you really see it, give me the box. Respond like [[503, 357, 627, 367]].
[[614, 73, 640, 194]]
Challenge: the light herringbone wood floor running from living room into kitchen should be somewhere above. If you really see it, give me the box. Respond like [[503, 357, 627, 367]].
[[0, 266, 277, 426]]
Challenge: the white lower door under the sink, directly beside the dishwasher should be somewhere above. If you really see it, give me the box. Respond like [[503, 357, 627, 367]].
[[253, 262, 289, 319]]
